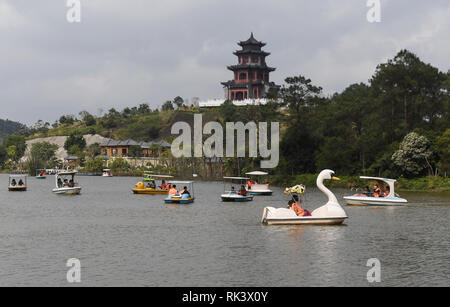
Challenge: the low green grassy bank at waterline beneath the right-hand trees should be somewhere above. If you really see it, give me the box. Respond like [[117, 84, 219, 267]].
[[269, 174, 450, 192]]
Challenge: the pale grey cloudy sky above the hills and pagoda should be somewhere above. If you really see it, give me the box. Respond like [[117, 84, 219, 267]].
[[0, 0, 450, 125]]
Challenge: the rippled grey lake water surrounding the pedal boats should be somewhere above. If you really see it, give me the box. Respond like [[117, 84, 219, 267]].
[[0, 175, 450, 287]]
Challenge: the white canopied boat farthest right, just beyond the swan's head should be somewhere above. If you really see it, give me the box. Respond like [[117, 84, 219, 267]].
[[344, 176, 408, 207]]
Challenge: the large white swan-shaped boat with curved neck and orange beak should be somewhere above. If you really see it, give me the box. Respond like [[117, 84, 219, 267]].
[[262, 170, 348, 225]]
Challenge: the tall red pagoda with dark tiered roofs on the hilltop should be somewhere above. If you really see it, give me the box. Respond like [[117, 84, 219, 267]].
[[222, 33, 279, 100]]
